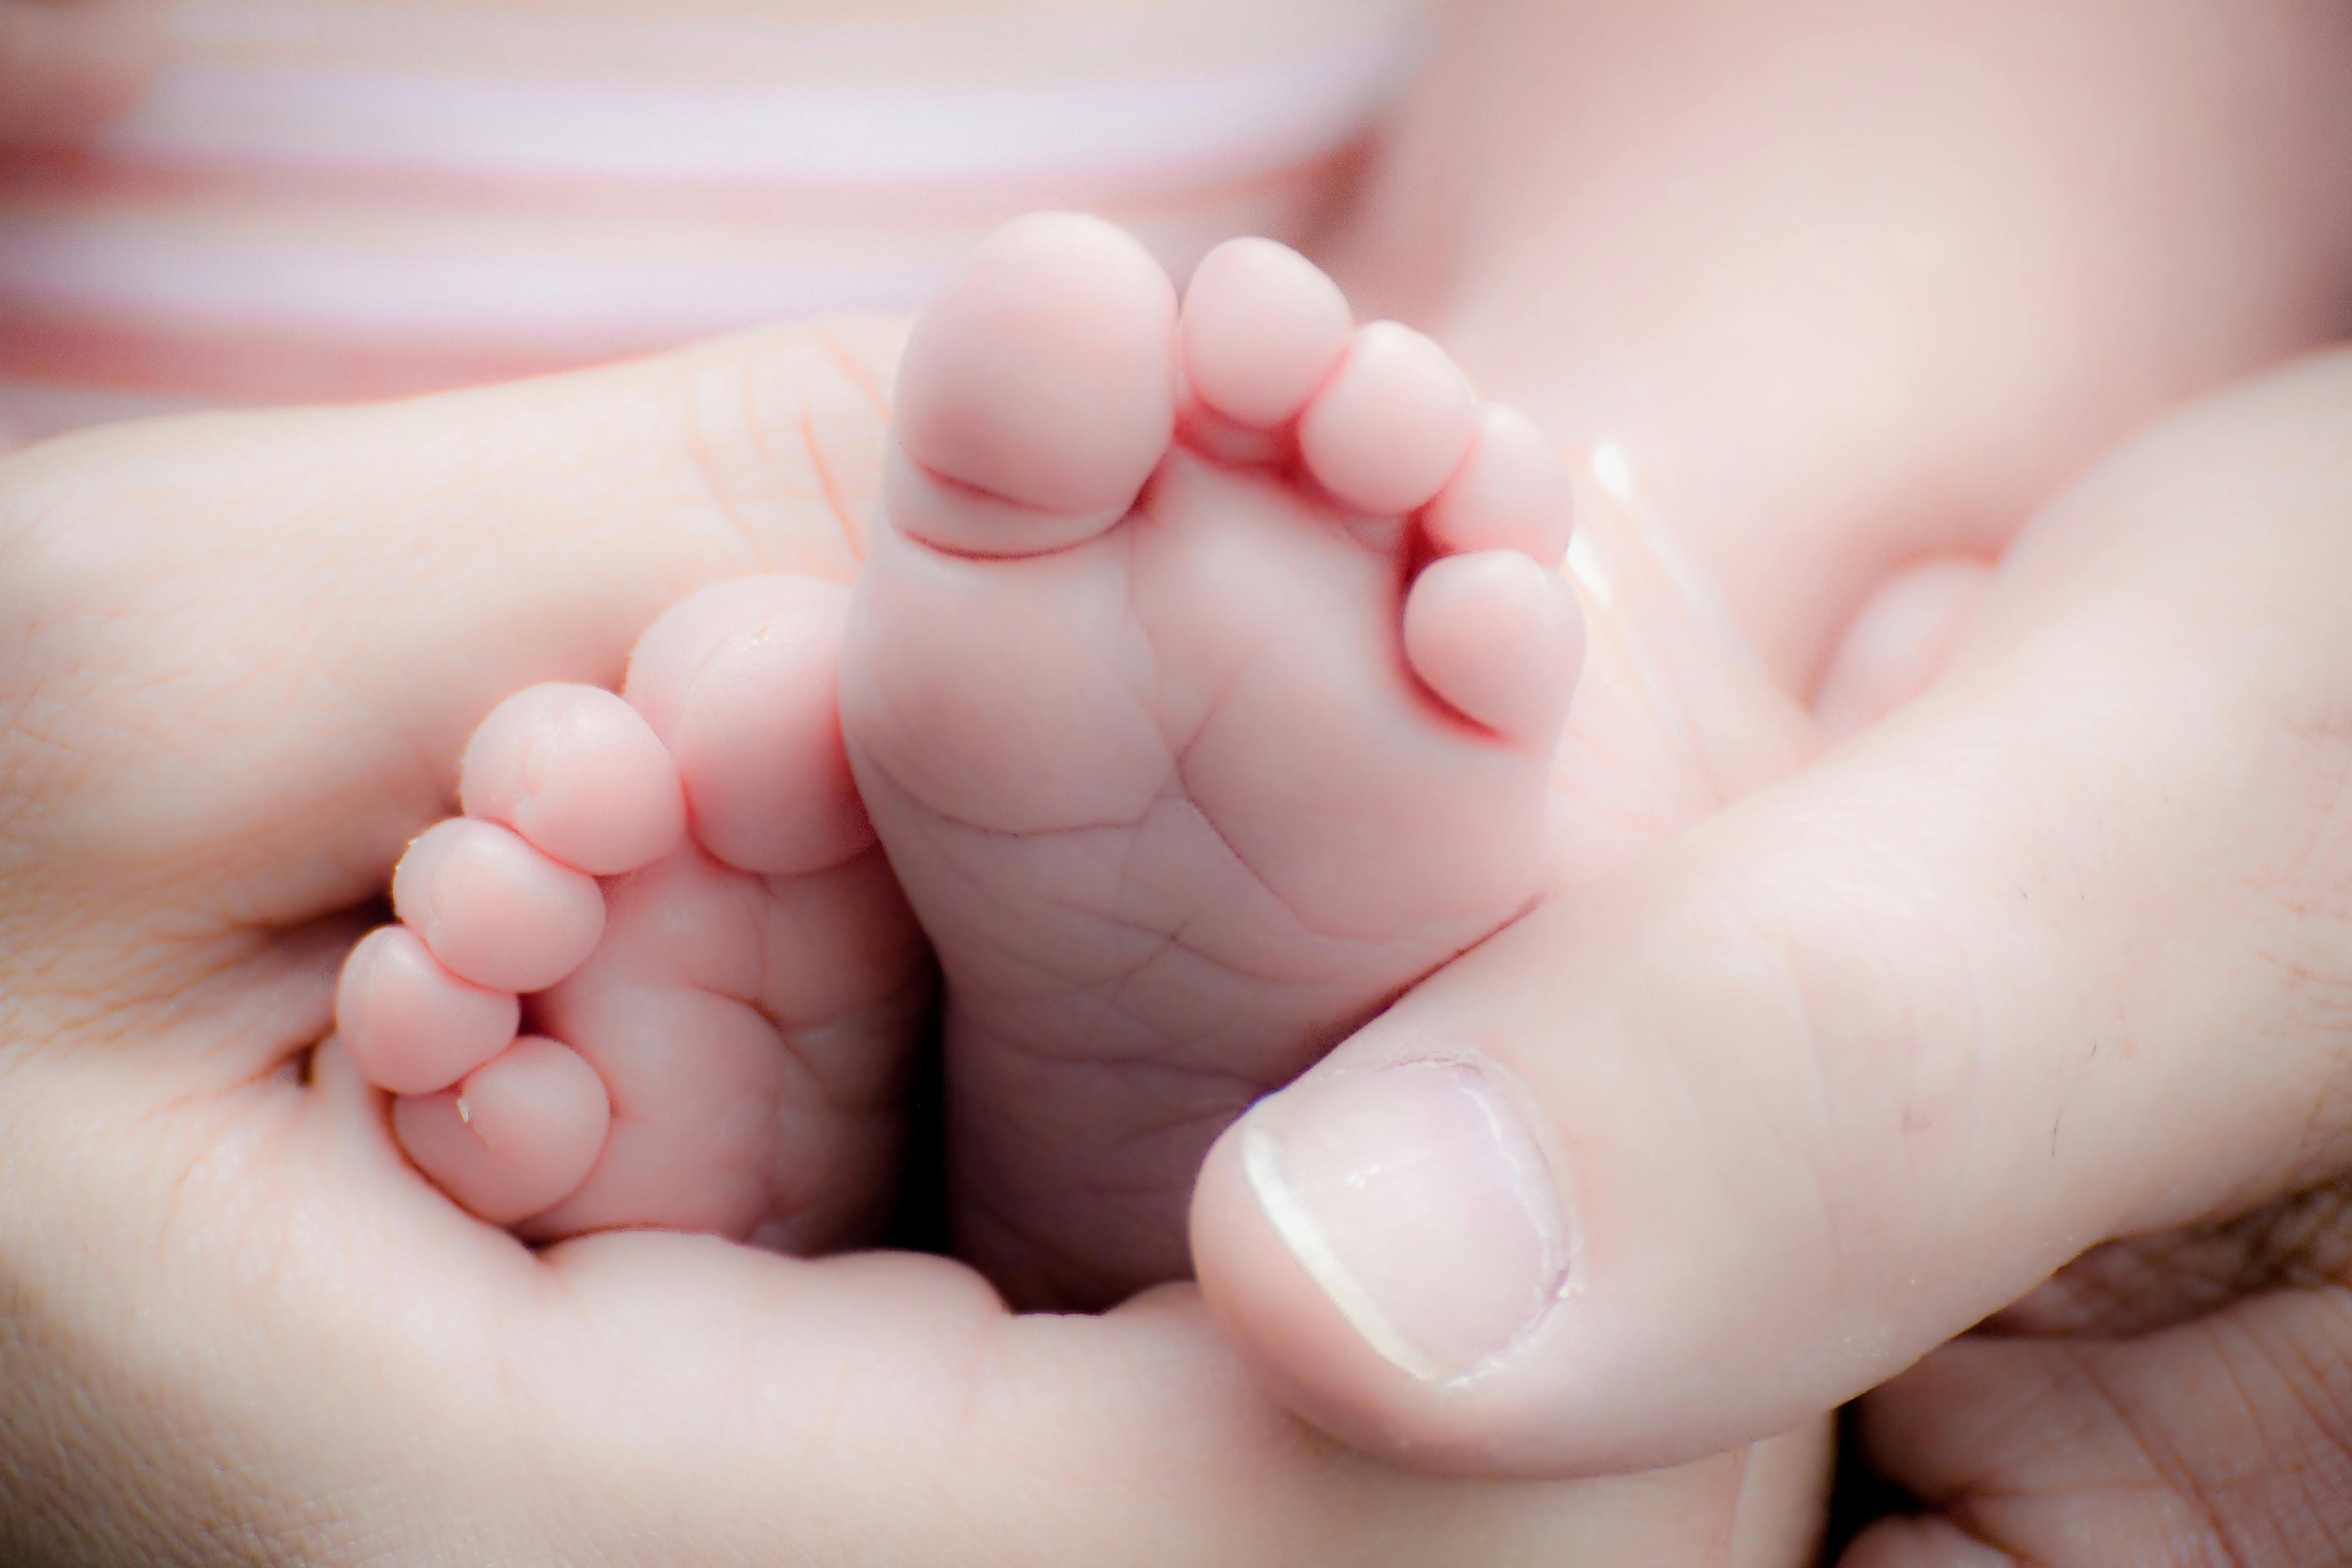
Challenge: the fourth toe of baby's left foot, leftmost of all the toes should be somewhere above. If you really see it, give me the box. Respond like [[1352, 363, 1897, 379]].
[[334, 926, 522, 1096]]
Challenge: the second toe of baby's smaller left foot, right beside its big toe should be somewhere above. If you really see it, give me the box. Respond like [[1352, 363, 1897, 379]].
[[459, 682, 687, 877]]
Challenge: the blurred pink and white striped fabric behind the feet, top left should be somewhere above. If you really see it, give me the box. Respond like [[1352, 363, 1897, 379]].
[[0, 0, 1418, 432]]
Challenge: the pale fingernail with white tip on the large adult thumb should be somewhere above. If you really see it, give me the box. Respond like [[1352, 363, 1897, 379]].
[[1242, 1060, 1573, 1382]]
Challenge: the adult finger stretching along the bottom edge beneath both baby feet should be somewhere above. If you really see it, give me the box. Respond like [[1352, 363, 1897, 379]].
[[0, 1029, 1769, 1568]]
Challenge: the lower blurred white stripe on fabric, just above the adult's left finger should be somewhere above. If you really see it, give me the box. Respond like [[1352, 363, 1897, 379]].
[[0, 219, 936, 341]]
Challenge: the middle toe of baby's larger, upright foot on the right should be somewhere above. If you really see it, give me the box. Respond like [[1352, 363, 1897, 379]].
[[1298, 322, 1477, 517]]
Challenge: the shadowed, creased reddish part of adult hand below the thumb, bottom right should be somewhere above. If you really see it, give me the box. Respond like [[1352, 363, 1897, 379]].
[[1842, 1180, 2352, 1568]]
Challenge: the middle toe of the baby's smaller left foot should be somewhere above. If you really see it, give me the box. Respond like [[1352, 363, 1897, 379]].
[[393, 818, 604, 992]]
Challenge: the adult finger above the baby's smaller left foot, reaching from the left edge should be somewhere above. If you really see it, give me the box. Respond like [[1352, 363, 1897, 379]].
[[0, 322, 898, 1029]]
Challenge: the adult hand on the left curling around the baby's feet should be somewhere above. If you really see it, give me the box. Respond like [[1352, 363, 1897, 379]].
[[0, 327, 1804, 1568]]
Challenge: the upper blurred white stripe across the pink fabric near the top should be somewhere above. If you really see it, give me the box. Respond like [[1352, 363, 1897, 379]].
[[101, 30, 1414, 186]]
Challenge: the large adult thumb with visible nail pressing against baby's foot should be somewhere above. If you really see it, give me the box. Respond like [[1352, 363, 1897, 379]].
[[1192, 355, 2352, 1474]]
